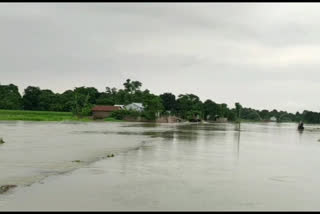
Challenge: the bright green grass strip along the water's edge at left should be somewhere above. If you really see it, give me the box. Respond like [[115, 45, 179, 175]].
[[0, 109, 81, 121]]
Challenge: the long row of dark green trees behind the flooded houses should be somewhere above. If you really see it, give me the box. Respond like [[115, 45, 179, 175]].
[[0, 79, 320, 123]]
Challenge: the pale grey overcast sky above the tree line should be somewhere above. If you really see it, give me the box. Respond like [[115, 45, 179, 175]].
[[0, 3, 320, 112]]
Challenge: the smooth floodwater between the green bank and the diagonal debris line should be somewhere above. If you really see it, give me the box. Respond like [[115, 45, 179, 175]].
[[0, 121, 148, 188]]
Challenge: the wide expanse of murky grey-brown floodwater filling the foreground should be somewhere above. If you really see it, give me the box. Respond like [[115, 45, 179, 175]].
[[0, 121, 320, 211]]
